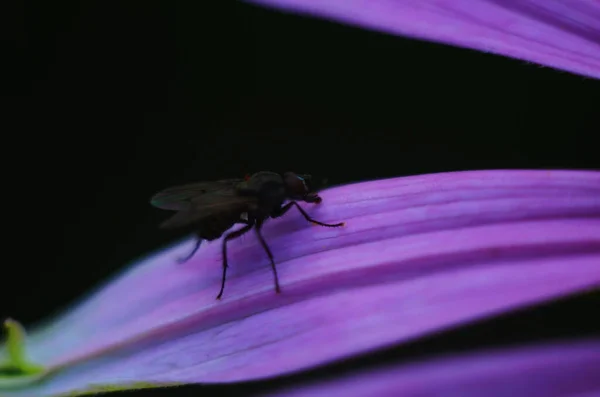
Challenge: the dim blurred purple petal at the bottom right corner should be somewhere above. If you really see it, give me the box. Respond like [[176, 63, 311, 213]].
[[269, 341, 600, 397]]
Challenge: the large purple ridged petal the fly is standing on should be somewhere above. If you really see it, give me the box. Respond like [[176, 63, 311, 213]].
[[1, 171, 600, 397]]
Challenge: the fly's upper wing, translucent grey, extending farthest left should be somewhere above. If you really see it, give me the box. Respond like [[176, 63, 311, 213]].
[[150, 179, 243, 211]]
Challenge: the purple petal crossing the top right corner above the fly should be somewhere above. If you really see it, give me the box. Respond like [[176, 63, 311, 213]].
[[248, 0, 600, 78]]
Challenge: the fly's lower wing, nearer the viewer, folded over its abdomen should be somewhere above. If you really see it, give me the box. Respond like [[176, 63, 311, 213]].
[[160, 189, 257, 229]]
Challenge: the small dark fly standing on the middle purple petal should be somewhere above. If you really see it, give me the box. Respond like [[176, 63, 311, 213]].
[[150, 171, 344, 299]]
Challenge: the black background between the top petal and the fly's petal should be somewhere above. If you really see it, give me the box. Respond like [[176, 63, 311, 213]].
[[0, 0, 600, 394]]
